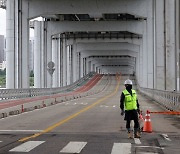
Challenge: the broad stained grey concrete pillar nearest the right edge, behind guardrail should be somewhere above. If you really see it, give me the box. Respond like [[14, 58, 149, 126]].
[[165, 0, 176, 90]]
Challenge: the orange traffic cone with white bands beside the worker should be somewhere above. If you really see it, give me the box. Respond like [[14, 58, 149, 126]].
[[143, 110, 152, 133]]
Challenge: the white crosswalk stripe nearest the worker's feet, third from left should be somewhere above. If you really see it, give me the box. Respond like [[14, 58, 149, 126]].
[[111, 143, 131, 154]]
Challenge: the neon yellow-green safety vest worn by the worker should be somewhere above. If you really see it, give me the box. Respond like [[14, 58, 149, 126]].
[[123, 89, 137, 111]]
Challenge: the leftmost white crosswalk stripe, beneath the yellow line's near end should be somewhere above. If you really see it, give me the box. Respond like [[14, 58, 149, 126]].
[[9, 141, 45, 152]]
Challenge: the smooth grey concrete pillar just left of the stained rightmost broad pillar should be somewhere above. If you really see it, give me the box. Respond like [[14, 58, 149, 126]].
[[154, 0, 166, 90]]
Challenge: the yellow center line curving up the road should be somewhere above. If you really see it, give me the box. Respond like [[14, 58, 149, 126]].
[[19, 78, 120, 142]]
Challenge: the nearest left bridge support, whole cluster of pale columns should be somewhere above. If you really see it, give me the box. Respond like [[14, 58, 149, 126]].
[[6, 0, 29, 88]]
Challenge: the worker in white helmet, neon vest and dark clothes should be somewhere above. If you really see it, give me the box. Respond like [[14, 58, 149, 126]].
[[120, 79, 140, 138]]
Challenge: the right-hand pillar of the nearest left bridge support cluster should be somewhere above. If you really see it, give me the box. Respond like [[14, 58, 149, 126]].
[[18, 0, 29, 88]]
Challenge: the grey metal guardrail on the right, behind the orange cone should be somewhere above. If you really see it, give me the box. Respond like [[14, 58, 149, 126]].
[[137, 86, 180, 111]]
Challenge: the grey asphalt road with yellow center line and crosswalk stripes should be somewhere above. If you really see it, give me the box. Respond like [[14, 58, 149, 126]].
[[0, 76, 180, 154]]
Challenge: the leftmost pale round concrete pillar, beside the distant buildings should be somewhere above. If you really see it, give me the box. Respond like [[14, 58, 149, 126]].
[[6, 0, 16, 89]]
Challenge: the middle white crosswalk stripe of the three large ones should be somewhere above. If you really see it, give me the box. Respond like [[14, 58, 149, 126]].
[[60, 142, 87, 153]]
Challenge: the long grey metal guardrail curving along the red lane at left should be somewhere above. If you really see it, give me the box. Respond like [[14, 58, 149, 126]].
[[0, 72, 95, 101]]
